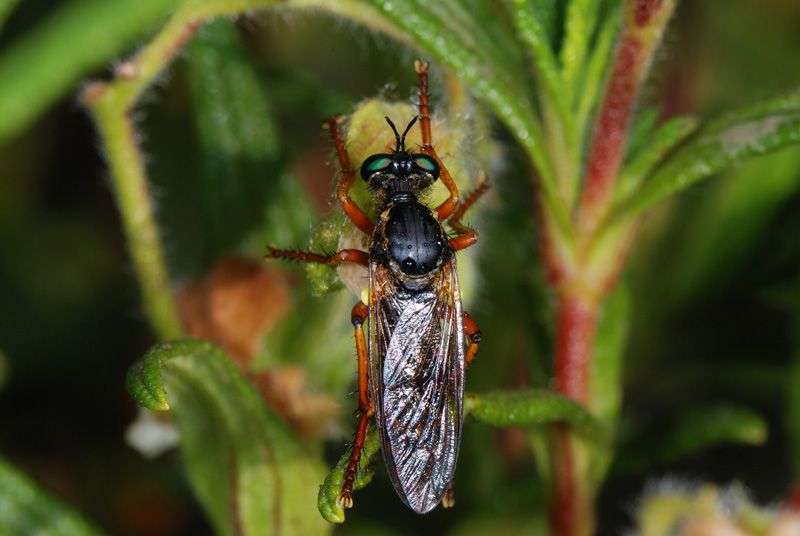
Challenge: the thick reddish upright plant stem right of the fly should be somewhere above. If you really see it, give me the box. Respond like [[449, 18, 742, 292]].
[[537, 5, 676, 536]]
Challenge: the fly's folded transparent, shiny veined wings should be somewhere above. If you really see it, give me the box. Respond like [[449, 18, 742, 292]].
[[369, 258, 464, 513]]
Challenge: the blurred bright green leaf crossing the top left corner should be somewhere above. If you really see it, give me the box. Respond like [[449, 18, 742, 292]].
[[0, 0, 178, 144]]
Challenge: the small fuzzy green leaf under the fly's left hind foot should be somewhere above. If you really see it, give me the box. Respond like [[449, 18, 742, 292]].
[[317, 426, 381, 523]]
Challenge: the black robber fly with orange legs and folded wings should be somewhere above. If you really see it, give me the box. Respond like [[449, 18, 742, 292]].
[[270, 62, 487, 513]]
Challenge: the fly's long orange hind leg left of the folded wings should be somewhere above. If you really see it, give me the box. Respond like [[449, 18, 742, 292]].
[[336, 302, 375, 508]]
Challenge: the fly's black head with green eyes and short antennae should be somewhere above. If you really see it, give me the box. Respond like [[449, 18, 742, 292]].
[[361, 117, 439, 197]]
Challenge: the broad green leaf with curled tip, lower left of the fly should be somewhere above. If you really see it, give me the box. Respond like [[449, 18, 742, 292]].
[[128, 340, 328, 535]]
